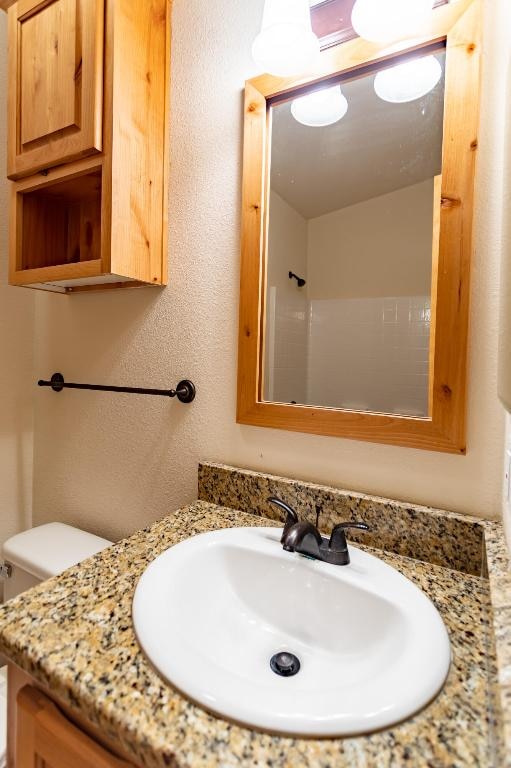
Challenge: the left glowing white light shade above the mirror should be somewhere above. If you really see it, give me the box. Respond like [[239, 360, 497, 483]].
[[252, 0, 320, 77]]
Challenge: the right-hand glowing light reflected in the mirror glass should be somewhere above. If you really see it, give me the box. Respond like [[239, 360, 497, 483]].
[[374, 56, 442, 104]]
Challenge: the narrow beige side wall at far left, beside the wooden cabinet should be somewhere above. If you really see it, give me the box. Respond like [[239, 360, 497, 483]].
[[0, 12, 35, 560]]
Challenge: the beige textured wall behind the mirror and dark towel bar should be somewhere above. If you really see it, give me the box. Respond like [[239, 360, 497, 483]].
[[34, 0, 509, 537]]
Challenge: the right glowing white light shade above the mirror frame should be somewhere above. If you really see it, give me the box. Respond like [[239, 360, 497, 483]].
[[351, 0, 434, 43]]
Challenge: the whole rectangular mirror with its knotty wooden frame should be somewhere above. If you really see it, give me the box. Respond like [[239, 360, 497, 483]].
[[237, 0, 481, 454]]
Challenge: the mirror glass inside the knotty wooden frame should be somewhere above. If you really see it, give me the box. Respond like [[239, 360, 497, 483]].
[[262, 49, 445, 417]]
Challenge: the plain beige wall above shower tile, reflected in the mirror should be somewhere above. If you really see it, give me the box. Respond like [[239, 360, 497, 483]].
[[308, 179, 434, 299]]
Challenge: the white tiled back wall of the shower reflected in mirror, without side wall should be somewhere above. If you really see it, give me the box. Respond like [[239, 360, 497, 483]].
[[307, 296, 431, 416]]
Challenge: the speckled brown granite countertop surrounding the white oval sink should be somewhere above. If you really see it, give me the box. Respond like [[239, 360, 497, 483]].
[[0, 501, 500, 768]]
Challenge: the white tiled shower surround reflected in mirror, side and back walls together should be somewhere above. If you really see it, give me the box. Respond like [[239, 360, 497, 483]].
[[267, 291, 431, 416]]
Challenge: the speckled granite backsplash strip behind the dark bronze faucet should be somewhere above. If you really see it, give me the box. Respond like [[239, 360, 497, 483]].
[[199, 463, 484, 576]]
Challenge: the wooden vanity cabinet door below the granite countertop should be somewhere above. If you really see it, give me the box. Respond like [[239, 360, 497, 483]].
[[15, 686, 134, 768]]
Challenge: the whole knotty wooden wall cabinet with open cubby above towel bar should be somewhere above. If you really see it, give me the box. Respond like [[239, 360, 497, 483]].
[[8, 0, 171, 293]]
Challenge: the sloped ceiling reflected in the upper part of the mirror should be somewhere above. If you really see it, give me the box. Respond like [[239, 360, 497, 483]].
[[271, 52, 445, 219]]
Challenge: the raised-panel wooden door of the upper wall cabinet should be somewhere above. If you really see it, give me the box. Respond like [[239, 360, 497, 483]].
[[7, 0, 104, 178]]
